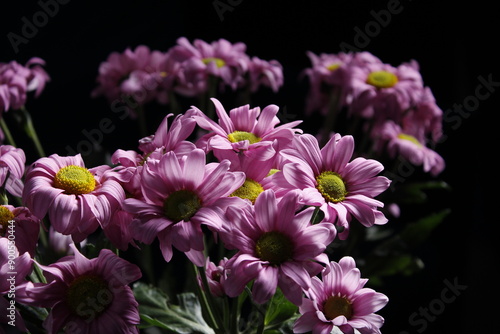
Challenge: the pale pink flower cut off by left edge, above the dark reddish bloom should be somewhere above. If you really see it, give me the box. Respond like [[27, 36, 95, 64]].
[[0, 145, 26, 197]]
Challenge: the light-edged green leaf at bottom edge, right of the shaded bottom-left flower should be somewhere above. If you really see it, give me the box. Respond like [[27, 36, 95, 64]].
[[133, 282, 215, 334]]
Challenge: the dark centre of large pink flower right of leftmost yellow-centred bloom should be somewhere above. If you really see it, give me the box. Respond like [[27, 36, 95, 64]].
[[163, 189, 201, 223]]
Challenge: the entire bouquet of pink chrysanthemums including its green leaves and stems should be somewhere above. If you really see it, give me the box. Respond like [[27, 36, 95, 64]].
[[0, 37, 448, 334]]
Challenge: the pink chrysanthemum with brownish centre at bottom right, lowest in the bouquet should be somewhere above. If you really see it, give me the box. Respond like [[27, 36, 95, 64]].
[[293, 256, 388, 334]]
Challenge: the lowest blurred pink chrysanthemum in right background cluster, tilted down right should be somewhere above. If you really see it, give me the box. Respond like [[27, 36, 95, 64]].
[[379, 121, 445, 176]]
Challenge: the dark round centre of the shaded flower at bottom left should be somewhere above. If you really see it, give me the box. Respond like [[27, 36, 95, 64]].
[[65, 274, 113, 320]]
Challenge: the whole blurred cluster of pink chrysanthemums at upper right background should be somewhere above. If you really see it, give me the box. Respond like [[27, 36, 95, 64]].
[[304, 52, 445, 176]]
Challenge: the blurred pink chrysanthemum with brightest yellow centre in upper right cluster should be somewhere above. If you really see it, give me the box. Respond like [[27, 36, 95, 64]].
[[349, 61, 424, 121]]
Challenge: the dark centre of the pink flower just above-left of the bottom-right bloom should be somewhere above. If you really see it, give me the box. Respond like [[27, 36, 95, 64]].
[[255, 231, 294, 265]]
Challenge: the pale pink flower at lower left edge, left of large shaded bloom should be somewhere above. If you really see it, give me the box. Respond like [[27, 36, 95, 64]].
[[0, 238, 33, 333]]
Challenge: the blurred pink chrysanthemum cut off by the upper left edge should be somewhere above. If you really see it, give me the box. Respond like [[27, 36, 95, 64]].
[[0, 57, 50, 114]]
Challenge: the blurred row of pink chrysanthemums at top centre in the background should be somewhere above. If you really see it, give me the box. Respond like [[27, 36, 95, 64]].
[[92, 37, 283, 111]]
